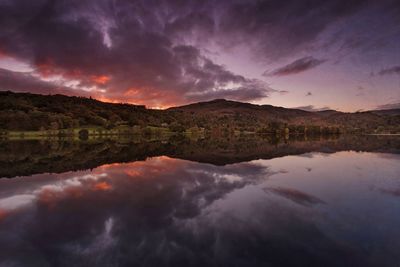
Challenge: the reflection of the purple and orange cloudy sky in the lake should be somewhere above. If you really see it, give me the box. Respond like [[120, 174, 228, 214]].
[[0, 152, 400, 266]]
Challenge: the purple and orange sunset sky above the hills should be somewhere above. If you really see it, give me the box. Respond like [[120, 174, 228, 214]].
[[0, 0, 400, 112]]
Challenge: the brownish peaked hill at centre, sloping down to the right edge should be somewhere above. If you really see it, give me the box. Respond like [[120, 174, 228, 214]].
[[169, 99, 400, 132]]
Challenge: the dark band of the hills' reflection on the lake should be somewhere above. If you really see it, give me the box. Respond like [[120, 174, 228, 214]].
[[0, 136, 400, 177]]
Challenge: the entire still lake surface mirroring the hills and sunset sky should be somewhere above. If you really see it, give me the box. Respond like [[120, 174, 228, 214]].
[[0, 136, 400, 266]]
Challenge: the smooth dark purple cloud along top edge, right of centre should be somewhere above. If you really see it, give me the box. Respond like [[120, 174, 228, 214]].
[[216, 0, 376, 60]]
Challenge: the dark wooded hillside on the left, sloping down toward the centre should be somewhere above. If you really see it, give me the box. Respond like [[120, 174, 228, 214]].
[[0, 92, 170, 130]]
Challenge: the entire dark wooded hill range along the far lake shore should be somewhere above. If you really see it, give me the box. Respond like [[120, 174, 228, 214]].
[[0, 91, 400, 134]]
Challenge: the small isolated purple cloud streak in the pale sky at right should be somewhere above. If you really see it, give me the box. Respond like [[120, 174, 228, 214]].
[[263, 57, 326, 76]]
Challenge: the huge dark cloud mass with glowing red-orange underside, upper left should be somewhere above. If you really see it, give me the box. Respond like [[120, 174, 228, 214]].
[[0, 1, 273, 104]]
